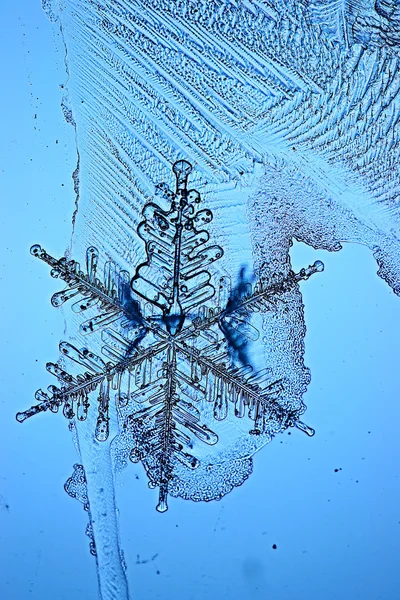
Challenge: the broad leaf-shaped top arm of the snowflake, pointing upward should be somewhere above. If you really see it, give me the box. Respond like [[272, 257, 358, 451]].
[[131, 160, 223, 336]]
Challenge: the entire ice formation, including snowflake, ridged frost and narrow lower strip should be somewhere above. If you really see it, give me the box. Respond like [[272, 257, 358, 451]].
[[17, 0, 400, 600]]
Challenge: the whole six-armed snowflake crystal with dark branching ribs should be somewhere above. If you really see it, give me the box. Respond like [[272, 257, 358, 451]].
[[16, 160, 323, 512]]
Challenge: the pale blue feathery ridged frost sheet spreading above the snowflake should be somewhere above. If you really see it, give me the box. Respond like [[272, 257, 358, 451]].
[[40, 0, 400, 293]]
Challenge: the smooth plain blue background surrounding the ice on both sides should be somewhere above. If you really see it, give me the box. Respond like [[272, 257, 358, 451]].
[[0, 0, 400, 600]]
